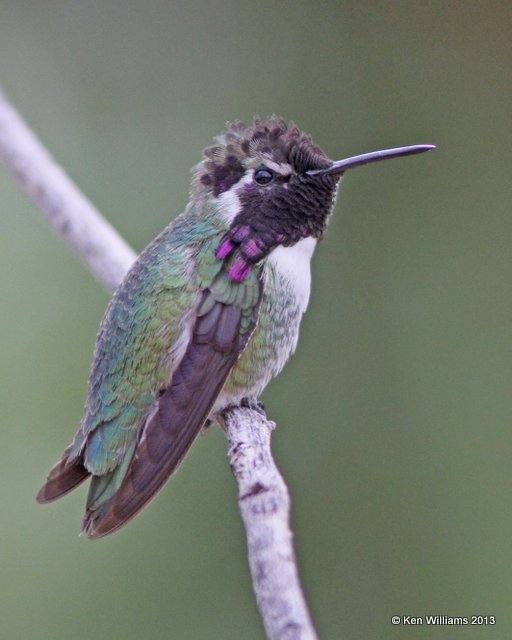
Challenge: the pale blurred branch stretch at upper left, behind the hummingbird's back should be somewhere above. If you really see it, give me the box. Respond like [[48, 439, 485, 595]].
[[0, 90, 137, 291]]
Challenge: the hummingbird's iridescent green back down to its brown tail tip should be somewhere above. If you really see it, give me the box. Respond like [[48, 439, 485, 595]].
[[37, 213, 218, 502]]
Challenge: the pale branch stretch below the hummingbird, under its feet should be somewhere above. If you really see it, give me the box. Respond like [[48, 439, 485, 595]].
[[224, 407, 317, 640]]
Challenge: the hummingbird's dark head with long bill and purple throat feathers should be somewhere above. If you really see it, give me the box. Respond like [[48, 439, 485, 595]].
[[193, 117, 432, 281]]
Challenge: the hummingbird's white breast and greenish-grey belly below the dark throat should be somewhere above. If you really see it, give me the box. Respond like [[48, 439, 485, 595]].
[[212, 238, 316, 414]]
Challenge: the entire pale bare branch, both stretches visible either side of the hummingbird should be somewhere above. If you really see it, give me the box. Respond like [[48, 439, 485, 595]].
[[0, 89, 317, 640]]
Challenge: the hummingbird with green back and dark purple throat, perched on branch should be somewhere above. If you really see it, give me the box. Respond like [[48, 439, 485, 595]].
[[37, 116, 434, 538]]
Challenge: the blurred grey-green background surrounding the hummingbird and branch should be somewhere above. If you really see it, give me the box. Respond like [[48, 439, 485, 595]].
[[0, 0, 512, 640]]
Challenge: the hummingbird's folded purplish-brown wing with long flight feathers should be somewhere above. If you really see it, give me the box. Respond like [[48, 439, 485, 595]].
[[83, 283, 261, 538]]
